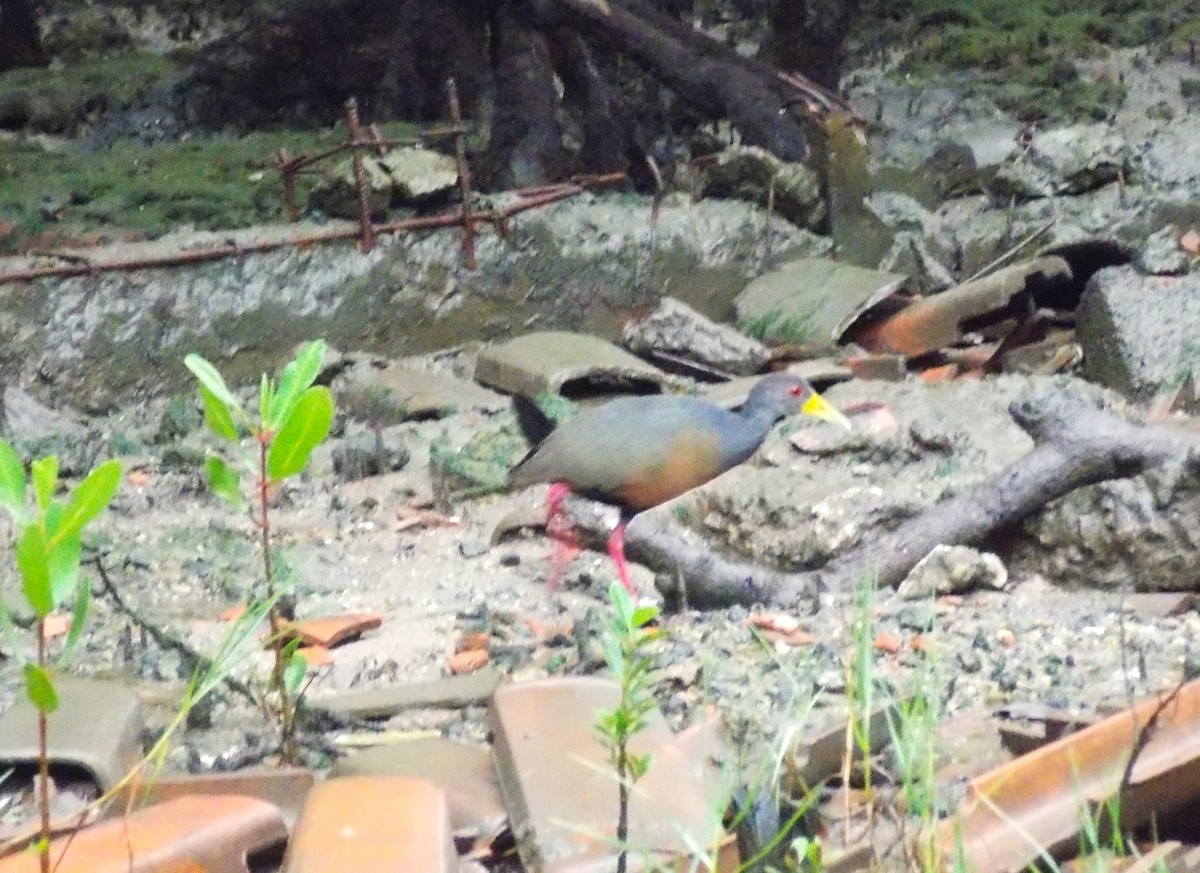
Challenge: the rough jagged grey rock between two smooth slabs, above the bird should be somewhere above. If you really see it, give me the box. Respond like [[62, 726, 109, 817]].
[[623, 297, 769, 375]]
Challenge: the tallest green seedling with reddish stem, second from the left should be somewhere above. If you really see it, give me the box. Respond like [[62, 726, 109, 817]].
[[184, 339, 334, 764]]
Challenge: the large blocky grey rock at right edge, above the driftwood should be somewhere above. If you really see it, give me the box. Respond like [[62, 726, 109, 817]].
[[1076, 266, 1200, 398]]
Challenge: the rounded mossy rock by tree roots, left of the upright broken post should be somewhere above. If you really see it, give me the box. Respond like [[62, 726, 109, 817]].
[[702, 145, 824, 228]]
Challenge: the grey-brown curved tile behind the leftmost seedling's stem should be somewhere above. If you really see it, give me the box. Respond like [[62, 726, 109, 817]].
[[0, 676, 142, 793]]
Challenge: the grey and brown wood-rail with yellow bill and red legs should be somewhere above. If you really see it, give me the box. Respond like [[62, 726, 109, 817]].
[[509, 373, 850, 594]]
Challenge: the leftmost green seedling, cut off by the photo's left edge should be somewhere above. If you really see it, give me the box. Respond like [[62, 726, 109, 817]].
[[0, 440, 121, 873]]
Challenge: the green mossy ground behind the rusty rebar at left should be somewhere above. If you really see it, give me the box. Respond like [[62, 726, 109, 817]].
[[0, 124, 422, 236]]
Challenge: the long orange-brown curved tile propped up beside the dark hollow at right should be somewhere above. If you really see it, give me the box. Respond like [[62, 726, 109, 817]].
[[846, 255, 1072, 356]]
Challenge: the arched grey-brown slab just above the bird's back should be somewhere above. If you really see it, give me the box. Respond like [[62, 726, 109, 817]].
[[475, 331, 666, 397]]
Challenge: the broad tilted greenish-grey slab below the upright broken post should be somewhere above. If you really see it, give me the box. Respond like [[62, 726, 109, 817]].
[[734, 258, 907, 349]]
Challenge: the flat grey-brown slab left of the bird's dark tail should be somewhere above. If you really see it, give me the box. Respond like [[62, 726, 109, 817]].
[[330, 359, 509, 426]]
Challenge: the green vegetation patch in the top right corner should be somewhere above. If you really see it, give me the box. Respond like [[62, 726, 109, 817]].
[[865, 0, 1200, 120]]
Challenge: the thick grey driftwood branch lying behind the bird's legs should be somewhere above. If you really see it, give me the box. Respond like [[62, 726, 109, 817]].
[[571, 392, 1200, 609]]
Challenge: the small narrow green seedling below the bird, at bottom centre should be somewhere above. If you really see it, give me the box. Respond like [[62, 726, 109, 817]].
[[595, 582, 659, 873]]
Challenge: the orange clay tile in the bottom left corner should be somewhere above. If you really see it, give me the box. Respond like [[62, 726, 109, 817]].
[[0, 795, 288, 873]]
